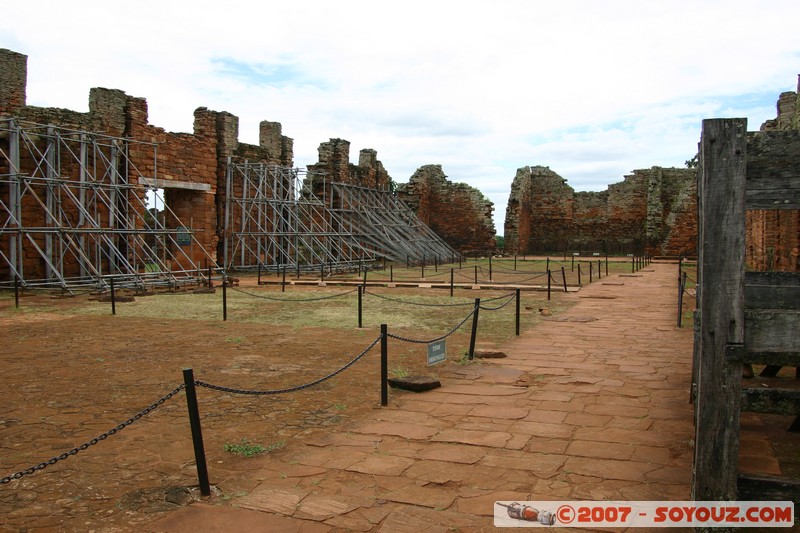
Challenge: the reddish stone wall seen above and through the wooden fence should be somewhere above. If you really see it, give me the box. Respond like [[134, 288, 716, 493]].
[[746, 76, 800, 272]]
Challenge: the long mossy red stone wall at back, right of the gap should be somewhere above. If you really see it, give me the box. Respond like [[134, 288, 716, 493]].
[[505, 166, 696, 255]]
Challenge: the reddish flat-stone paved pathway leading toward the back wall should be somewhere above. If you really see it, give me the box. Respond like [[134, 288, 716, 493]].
[[150, 263, 694, 533]]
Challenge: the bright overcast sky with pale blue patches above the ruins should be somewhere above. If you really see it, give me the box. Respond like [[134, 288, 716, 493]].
[[0, 0, 800, 234]]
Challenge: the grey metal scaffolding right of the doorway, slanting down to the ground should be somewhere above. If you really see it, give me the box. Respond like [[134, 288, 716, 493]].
[[224, 159, 458, 272]]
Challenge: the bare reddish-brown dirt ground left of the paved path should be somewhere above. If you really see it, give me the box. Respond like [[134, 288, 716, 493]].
[[0, 270, 556, 531]]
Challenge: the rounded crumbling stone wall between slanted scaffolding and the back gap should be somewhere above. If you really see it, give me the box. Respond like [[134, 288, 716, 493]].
[[397, 165, 495, 253]]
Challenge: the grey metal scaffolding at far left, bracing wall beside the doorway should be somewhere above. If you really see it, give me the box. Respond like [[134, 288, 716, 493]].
[[0, 119, 216, 291]]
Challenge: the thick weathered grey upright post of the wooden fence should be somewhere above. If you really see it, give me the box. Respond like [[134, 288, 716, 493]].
[[692, 119, 747, 501]]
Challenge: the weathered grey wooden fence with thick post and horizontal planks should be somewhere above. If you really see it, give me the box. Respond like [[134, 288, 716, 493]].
[[692, 119, 800, 505]]
